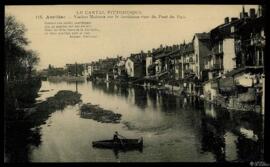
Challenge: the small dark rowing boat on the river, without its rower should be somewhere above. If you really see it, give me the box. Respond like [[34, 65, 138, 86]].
[[92, 138, 143, 149]]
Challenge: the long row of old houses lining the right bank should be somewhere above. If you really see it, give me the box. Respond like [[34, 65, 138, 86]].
[[87, 6, 265, 113]]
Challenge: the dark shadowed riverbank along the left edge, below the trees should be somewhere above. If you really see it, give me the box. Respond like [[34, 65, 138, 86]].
[[4, 76, 42, 162]]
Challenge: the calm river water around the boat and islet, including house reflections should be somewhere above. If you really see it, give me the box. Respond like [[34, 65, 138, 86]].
[[25, 81, 263, 162]]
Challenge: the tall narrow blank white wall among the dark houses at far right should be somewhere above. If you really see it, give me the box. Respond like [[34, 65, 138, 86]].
[[223, 38, 236, 73]]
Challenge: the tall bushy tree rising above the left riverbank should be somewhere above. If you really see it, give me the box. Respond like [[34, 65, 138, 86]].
[[5, 16, 39, 80]]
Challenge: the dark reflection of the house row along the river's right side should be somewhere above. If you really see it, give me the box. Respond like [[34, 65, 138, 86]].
[[89, 81, 263, 161]]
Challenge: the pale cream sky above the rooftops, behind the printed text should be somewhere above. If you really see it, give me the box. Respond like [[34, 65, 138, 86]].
[[5, 5, 258, 69]]
